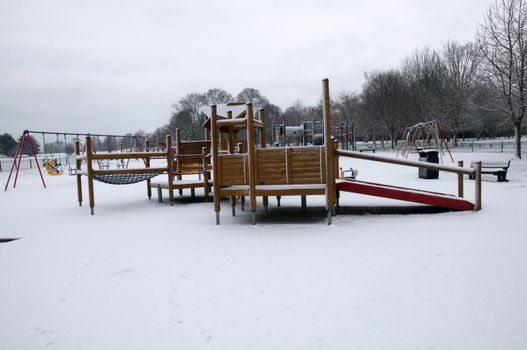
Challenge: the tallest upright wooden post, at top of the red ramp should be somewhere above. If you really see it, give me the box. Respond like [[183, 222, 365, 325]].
[[322, 79, 335, 225]]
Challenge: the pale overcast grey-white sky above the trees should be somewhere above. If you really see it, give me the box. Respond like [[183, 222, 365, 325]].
[[0, 0, 491, 134]]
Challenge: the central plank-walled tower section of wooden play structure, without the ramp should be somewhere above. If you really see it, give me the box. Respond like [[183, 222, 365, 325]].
[[211, 79, 337, 225]]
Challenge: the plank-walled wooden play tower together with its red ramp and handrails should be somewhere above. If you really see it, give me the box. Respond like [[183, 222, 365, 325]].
[[210, 79, 481, 224]]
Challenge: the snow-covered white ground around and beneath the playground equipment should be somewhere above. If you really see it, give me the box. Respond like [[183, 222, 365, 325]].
[[0, 153, 527, 349]]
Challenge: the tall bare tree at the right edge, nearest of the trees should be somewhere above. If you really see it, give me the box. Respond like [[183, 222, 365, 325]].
[[477, 0, 527, 158]]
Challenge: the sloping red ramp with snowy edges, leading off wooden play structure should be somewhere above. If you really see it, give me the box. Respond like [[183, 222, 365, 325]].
[[336, 180, 474, 210]]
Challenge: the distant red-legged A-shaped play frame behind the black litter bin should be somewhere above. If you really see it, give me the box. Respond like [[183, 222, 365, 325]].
[[397, 120, 454, 163]]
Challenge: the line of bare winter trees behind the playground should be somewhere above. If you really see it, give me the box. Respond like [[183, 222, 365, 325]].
[[154, 0, 527, 157]]
